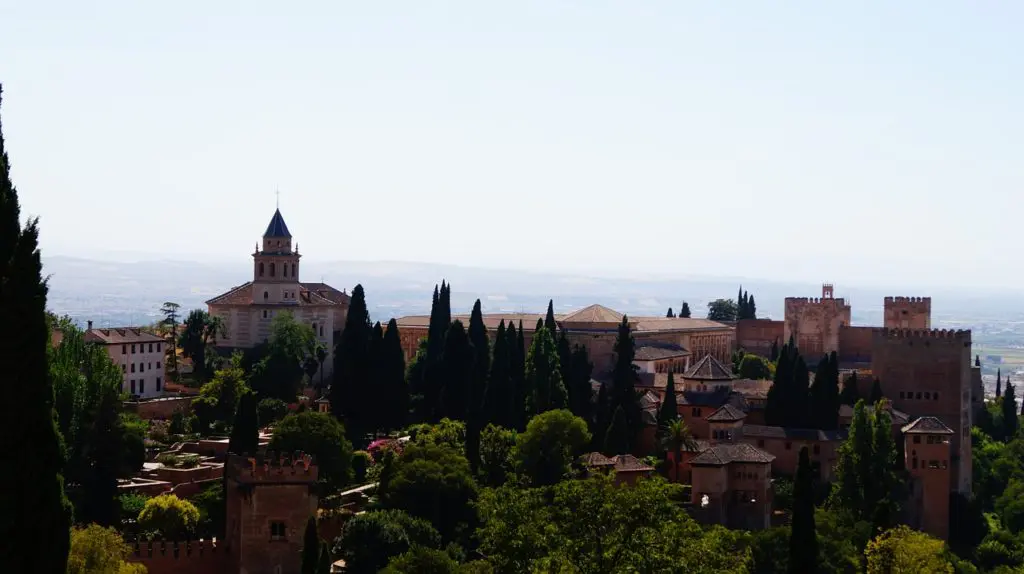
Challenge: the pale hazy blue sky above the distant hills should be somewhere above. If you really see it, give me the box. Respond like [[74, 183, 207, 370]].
[[0, 0, 1024, 286]]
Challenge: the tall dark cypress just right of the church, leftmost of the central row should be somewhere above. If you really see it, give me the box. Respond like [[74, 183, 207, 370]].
[[331, 284, 379, 442]]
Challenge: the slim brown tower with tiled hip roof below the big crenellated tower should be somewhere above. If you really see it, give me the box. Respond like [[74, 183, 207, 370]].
[[902, 416, 953, 540]]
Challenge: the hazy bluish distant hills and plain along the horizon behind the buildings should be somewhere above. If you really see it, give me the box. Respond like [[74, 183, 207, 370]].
[[44, 257, 1024, 335]]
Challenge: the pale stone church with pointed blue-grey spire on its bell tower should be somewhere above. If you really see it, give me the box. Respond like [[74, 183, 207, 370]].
[[206, 210, 349, 377]]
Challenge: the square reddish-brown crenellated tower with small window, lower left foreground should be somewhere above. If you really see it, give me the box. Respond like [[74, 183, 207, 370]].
[[224, 452, 317, 574]]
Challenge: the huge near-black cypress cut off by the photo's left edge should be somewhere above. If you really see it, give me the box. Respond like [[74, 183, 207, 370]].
[[0, 88, 71, 573]]
